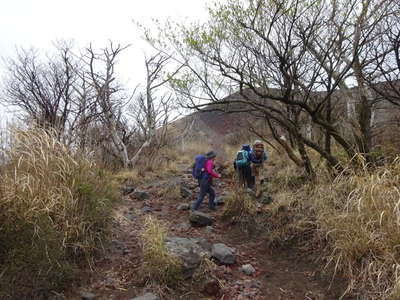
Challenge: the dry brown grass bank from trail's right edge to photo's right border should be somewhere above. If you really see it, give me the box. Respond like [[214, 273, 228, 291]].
[[265, 151, 400, 299]]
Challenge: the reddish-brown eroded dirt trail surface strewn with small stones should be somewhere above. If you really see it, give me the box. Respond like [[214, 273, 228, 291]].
[[63, 166, 350, 300]]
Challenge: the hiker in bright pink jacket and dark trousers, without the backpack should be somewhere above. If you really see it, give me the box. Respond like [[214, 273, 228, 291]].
[[192, 151, 221, 211]]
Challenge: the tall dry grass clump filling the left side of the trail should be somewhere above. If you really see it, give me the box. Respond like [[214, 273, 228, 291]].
[[0, 129, 117, 298]]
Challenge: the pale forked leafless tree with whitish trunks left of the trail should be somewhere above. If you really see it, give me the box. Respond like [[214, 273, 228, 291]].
[[86, 42, 177, 168]]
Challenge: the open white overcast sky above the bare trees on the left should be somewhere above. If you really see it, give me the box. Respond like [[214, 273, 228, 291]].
[[0, 0, 215, 123]]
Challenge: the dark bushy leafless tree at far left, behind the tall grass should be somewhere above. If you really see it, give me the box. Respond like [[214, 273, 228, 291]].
[[2, 45, 77, 132]]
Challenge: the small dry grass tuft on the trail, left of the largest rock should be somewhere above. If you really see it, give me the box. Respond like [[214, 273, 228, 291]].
[[141, 216, 182, 285]]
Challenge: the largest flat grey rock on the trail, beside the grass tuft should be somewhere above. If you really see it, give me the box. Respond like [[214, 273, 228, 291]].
[[165, 237, 211, 278]]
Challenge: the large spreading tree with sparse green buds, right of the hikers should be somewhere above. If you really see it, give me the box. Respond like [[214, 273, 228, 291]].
[[147, 0, 396, 175]]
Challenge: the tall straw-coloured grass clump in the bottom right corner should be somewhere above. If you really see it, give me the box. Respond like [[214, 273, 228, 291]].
[[315, 158, 400, 299]]
